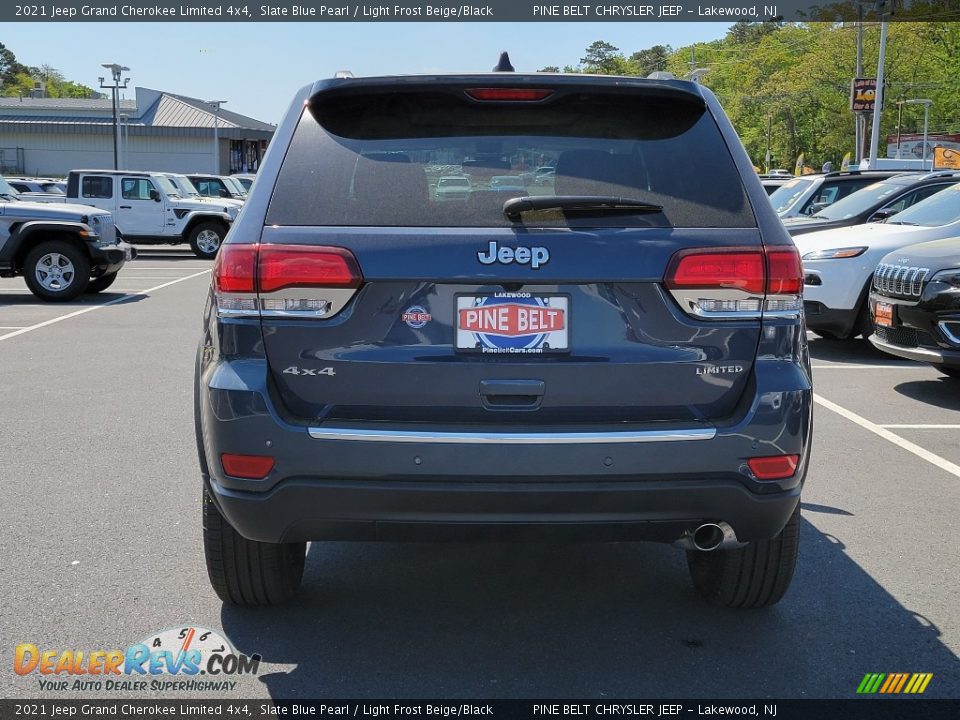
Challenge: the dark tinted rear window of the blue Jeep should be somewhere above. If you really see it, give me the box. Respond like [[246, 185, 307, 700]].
[[266, 86, 756, 227]]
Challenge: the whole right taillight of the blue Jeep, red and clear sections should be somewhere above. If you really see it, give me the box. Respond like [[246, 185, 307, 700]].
[[664, 247, 803, 319]]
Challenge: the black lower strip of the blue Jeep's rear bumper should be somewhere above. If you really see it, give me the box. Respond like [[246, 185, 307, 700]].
[[209, 478, 800, 542]]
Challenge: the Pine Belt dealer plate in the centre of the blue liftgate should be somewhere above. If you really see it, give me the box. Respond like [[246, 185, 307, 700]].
[[455, 292, 570, 355]]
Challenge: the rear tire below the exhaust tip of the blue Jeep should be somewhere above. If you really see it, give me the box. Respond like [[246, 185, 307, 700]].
[[687, 503, 800, 608]]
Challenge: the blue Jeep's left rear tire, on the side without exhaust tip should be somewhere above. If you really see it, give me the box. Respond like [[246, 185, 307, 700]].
[[203, 491, 307, 605]]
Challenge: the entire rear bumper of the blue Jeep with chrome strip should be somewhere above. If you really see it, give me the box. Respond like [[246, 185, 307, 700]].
[[197, 360, 811, 542]]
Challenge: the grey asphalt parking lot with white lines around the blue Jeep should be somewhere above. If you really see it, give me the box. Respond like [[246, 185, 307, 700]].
[[0, 249, 960, 699]]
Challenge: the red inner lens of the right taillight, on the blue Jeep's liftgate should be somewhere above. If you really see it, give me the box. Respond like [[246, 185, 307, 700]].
[[665, 248, 766, 295]]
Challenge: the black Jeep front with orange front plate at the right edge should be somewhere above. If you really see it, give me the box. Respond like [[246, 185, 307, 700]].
[[870, 237, 960, 378]]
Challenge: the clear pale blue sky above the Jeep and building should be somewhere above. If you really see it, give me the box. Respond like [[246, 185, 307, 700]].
[[7, 22, 729, 123]]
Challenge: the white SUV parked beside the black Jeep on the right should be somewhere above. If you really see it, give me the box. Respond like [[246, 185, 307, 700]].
[[793, 183, 960, 338]]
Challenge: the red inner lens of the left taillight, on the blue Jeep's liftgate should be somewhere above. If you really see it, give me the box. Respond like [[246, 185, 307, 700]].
[[257, 245, 363, 293]]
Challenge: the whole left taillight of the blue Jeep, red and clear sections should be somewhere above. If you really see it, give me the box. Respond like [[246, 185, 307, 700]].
[[213, 243, 363, 317]]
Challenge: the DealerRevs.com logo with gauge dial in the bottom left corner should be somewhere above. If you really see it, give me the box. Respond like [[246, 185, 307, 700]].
[[13, 626, 261, 692]]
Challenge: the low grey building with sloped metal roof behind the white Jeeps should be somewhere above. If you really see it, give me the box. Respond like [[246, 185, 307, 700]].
[[0, 87, 276, 176]]
